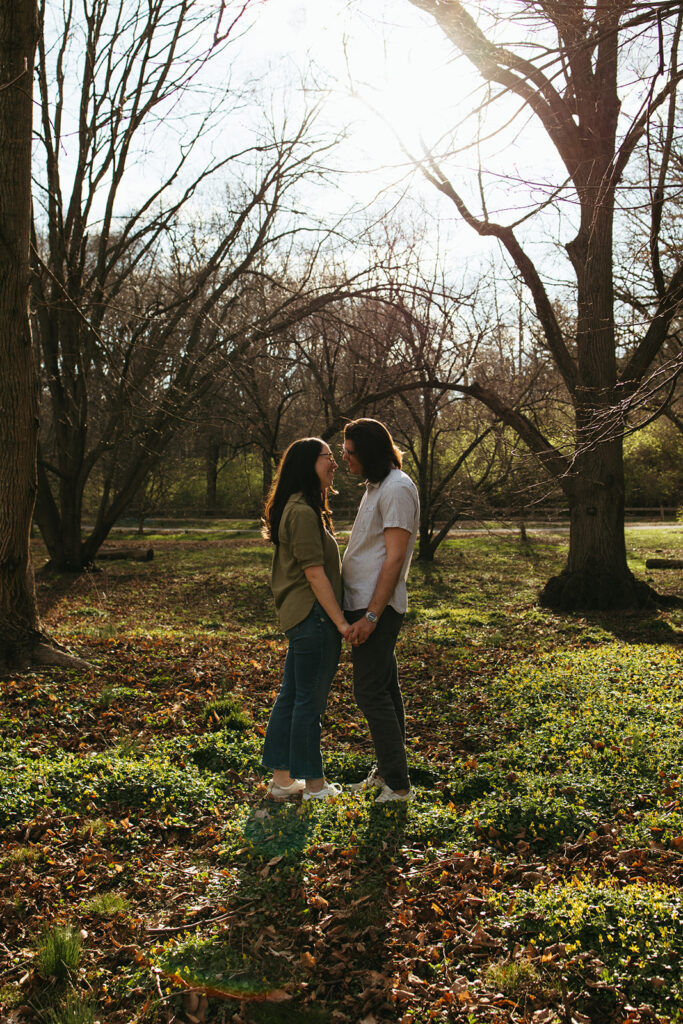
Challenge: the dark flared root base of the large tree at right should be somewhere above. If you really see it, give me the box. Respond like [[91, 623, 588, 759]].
[[539, 569, 683, 611]]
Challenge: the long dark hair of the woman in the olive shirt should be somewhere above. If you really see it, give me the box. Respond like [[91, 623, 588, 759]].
[[262, 437, 334, 544]]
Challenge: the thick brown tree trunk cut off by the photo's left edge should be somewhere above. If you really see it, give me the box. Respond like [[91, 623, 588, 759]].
[[0, 0, 40, 666]]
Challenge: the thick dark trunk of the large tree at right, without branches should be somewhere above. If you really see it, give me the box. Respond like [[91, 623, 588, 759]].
[[541, 163, 654, 610]]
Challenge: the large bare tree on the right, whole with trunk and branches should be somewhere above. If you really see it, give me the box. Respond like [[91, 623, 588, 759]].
[[403, 0, 683, 608]]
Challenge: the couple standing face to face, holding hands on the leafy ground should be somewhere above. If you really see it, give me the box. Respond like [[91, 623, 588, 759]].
[[261, 419, 420, 804]]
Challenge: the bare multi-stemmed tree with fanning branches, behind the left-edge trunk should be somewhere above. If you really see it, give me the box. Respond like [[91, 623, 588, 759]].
[[34, 0, 358, 570]]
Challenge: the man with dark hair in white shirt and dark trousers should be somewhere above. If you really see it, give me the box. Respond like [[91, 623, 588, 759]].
[[342, 419, 420, 804]]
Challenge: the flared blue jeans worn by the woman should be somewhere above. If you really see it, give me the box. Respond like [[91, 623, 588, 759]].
[[261, 601, 341, 778]]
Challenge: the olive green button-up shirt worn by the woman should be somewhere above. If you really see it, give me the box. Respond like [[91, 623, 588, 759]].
[[270, 494, 341, 630]]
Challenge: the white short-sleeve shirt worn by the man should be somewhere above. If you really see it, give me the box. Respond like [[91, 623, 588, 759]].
[[342, 469, 420, 613]]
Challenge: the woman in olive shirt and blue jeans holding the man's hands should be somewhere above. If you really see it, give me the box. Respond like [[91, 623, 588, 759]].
[[261, 437, 349, 800]]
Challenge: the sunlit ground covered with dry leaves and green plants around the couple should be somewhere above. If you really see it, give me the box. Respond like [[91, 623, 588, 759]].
[[0, 526, 683, 1024]]
